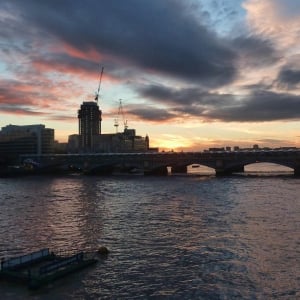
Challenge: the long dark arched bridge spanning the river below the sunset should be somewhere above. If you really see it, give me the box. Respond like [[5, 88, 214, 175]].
[[21, 149, 300, 175]]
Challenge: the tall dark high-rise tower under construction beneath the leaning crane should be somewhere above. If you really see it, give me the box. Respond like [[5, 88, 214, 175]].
[[78, 101, 102, 152]]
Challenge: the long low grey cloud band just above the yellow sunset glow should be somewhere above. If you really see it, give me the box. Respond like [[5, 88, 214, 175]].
[[136, 85, 300, 122]]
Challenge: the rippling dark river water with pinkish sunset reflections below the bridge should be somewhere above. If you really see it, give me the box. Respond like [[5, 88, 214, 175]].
[[0, 170, 300, 299]]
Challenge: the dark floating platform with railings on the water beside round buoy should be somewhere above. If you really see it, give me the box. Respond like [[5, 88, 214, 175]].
[[0, 248, 98, 289]]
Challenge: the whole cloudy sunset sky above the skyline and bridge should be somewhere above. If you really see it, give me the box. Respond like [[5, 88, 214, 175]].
[[0, 0, 300, 151]]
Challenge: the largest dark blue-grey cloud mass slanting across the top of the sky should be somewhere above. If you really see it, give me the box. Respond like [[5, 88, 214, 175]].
[[5, 0, 236, 86]]
